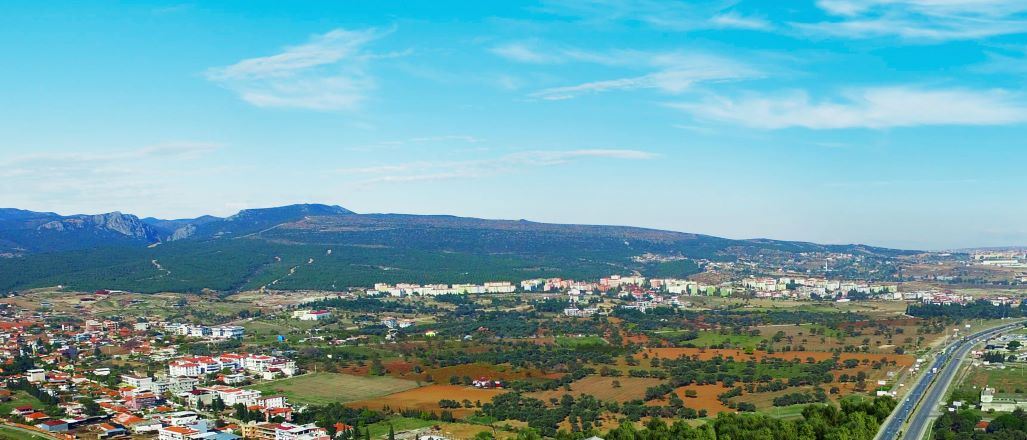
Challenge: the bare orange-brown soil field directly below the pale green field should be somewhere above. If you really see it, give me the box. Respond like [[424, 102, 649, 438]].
[[346, 384, 507, 417]]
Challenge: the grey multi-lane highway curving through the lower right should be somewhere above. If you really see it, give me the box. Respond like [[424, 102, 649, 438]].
[[877, 322, 1023, 440]]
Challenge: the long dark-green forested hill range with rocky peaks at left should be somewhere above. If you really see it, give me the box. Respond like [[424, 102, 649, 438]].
[[0, 205, 910, 292]]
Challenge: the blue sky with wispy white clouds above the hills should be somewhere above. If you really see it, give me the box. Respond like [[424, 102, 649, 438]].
[[0, 0, 1027, 249]]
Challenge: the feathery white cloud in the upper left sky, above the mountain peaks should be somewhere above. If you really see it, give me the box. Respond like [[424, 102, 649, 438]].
[[206, 29, 387, 110]]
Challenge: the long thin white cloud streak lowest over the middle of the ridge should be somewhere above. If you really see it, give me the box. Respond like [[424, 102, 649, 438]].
[[339, 148, 656, 185]]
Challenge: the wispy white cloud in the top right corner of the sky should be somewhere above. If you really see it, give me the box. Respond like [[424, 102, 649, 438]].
[[793, 0, 1027, 42]]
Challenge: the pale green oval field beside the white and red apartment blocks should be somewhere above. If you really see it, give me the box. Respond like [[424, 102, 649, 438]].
[[246, 373, 417, 405]]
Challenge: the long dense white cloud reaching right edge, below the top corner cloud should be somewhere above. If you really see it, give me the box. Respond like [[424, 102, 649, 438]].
[[672, 86, 1027, 130]]
